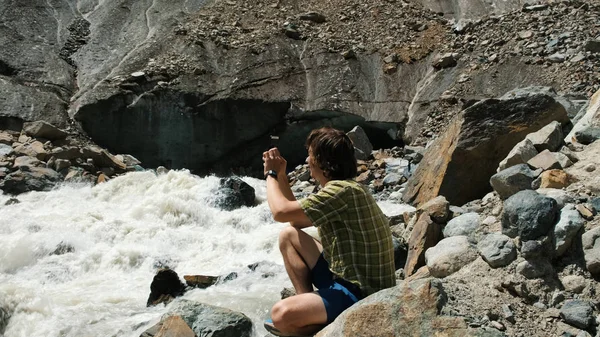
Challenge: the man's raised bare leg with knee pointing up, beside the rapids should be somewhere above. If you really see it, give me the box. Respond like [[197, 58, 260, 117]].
[[279, 226, 323, 294]]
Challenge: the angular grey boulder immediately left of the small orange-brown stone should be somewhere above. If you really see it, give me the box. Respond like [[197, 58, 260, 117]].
[[490, 164, 537, 199]]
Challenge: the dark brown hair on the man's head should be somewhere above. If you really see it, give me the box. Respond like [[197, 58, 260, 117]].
[[306, 127, 357, 180]]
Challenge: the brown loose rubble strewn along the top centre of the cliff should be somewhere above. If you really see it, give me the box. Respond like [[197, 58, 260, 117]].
[[176, 0, 451, 57]]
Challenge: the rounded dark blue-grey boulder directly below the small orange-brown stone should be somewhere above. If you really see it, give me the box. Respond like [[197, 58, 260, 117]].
[[502, 190, 558, 241]]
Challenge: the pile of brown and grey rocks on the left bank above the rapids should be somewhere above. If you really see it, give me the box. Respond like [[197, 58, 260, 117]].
[[0, 121, 143, 195]]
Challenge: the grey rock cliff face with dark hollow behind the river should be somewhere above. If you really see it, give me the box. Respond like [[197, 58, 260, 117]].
[[0, 0, 591, 171]]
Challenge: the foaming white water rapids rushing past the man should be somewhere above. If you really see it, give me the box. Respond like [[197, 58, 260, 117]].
[[0, 171, 298, 337]]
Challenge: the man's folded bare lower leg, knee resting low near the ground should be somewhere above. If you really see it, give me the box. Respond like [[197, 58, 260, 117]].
[[271, 292, 327, 335]]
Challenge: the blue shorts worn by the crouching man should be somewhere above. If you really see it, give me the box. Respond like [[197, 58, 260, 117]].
[[311, 254, 362, 324]]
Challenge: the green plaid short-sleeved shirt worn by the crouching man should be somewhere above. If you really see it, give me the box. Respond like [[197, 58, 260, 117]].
[[300, 180, 396, 296]]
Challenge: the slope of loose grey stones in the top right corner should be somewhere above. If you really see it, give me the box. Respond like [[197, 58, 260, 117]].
[[442, 1, 600, 97]]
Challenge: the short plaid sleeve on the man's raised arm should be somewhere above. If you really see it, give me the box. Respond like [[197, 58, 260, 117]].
[[300, 184, 348, 227]]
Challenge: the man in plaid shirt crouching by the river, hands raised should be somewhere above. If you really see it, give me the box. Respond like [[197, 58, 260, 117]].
[[263, 128, 395, 336]]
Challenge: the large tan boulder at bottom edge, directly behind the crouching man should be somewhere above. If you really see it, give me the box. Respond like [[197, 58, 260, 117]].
[[315, 278, 490, 337]]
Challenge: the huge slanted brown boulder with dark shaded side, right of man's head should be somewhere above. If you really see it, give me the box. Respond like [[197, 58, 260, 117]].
[[403, 95, 568, 205]]
